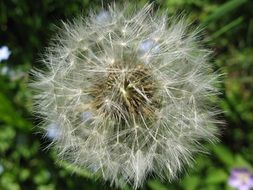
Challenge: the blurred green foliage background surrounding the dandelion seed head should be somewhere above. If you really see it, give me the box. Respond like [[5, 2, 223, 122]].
[[0, 0, 253, 190]]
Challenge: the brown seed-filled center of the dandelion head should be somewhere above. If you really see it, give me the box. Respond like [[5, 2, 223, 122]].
[[91, 62, 159, 120]]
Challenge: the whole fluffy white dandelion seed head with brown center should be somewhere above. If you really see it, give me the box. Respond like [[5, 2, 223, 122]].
[[32, 5, 221, 188]]
